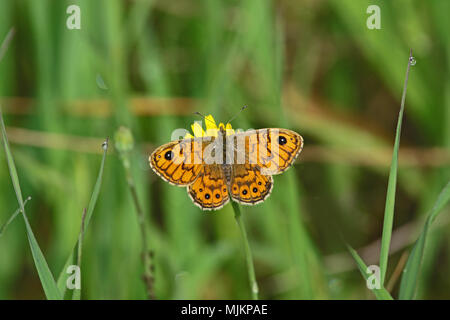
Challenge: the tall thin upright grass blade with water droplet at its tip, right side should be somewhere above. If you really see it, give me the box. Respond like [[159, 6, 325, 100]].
[[380, 51, 412, 285]]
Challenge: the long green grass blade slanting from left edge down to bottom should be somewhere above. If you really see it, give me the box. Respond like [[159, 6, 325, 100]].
[[0, 109, 61, 300]]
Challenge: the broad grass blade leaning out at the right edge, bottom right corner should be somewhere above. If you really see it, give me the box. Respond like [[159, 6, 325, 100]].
[[399, 182, 450, 300]]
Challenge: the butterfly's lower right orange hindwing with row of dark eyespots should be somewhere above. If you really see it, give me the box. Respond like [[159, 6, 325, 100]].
[[230, 164, 273, 205]]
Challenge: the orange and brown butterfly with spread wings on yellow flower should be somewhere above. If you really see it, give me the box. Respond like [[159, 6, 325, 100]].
[[149, 115, 303, 210]]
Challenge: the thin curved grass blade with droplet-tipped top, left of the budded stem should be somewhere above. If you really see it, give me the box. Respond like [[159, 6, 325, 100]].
[[57, 139, 108, 299]]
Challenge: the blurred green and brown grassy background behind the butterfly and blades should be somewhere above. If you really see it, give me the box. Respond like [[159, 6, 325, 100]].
[[0, 0, 450, 299]]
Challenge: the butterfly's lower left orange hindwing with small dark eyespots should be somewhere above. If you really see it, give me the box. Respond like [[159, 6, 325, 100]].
[[188, 164, 229, 210]]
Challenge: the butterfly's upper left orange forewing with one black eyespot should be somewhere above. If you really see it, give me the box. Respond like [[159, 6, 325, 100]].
[[149, 139, 205, 186]]
